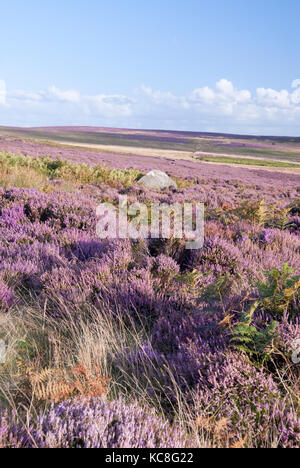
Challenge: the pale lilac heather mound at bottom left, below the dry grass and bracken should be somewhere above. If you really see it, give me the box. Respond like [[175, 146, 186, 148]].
[[0, 398, 195, 448]]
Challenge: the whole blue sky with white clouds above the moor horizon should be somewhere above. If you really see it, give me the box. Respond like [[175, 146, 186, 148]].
[[0, 0, 300, 136]]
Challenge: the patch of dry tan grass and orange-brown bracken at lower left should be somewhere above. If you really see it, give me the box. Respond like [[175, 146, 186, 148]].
[[0, 298, 296, 448]]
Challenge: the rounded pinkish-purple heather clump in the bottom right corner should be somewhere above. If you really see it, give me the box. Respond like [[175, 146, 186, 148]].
[[196, 355, 300, 448]]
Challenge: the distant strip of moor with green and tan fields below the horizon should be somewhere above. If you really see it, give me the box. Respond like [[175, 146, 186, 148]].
[[0, 127, 300, 167]]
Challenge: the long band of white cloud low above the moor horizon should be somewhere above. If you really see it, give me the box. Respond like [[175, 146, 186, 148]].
[[0, 78, 300, 135]]
